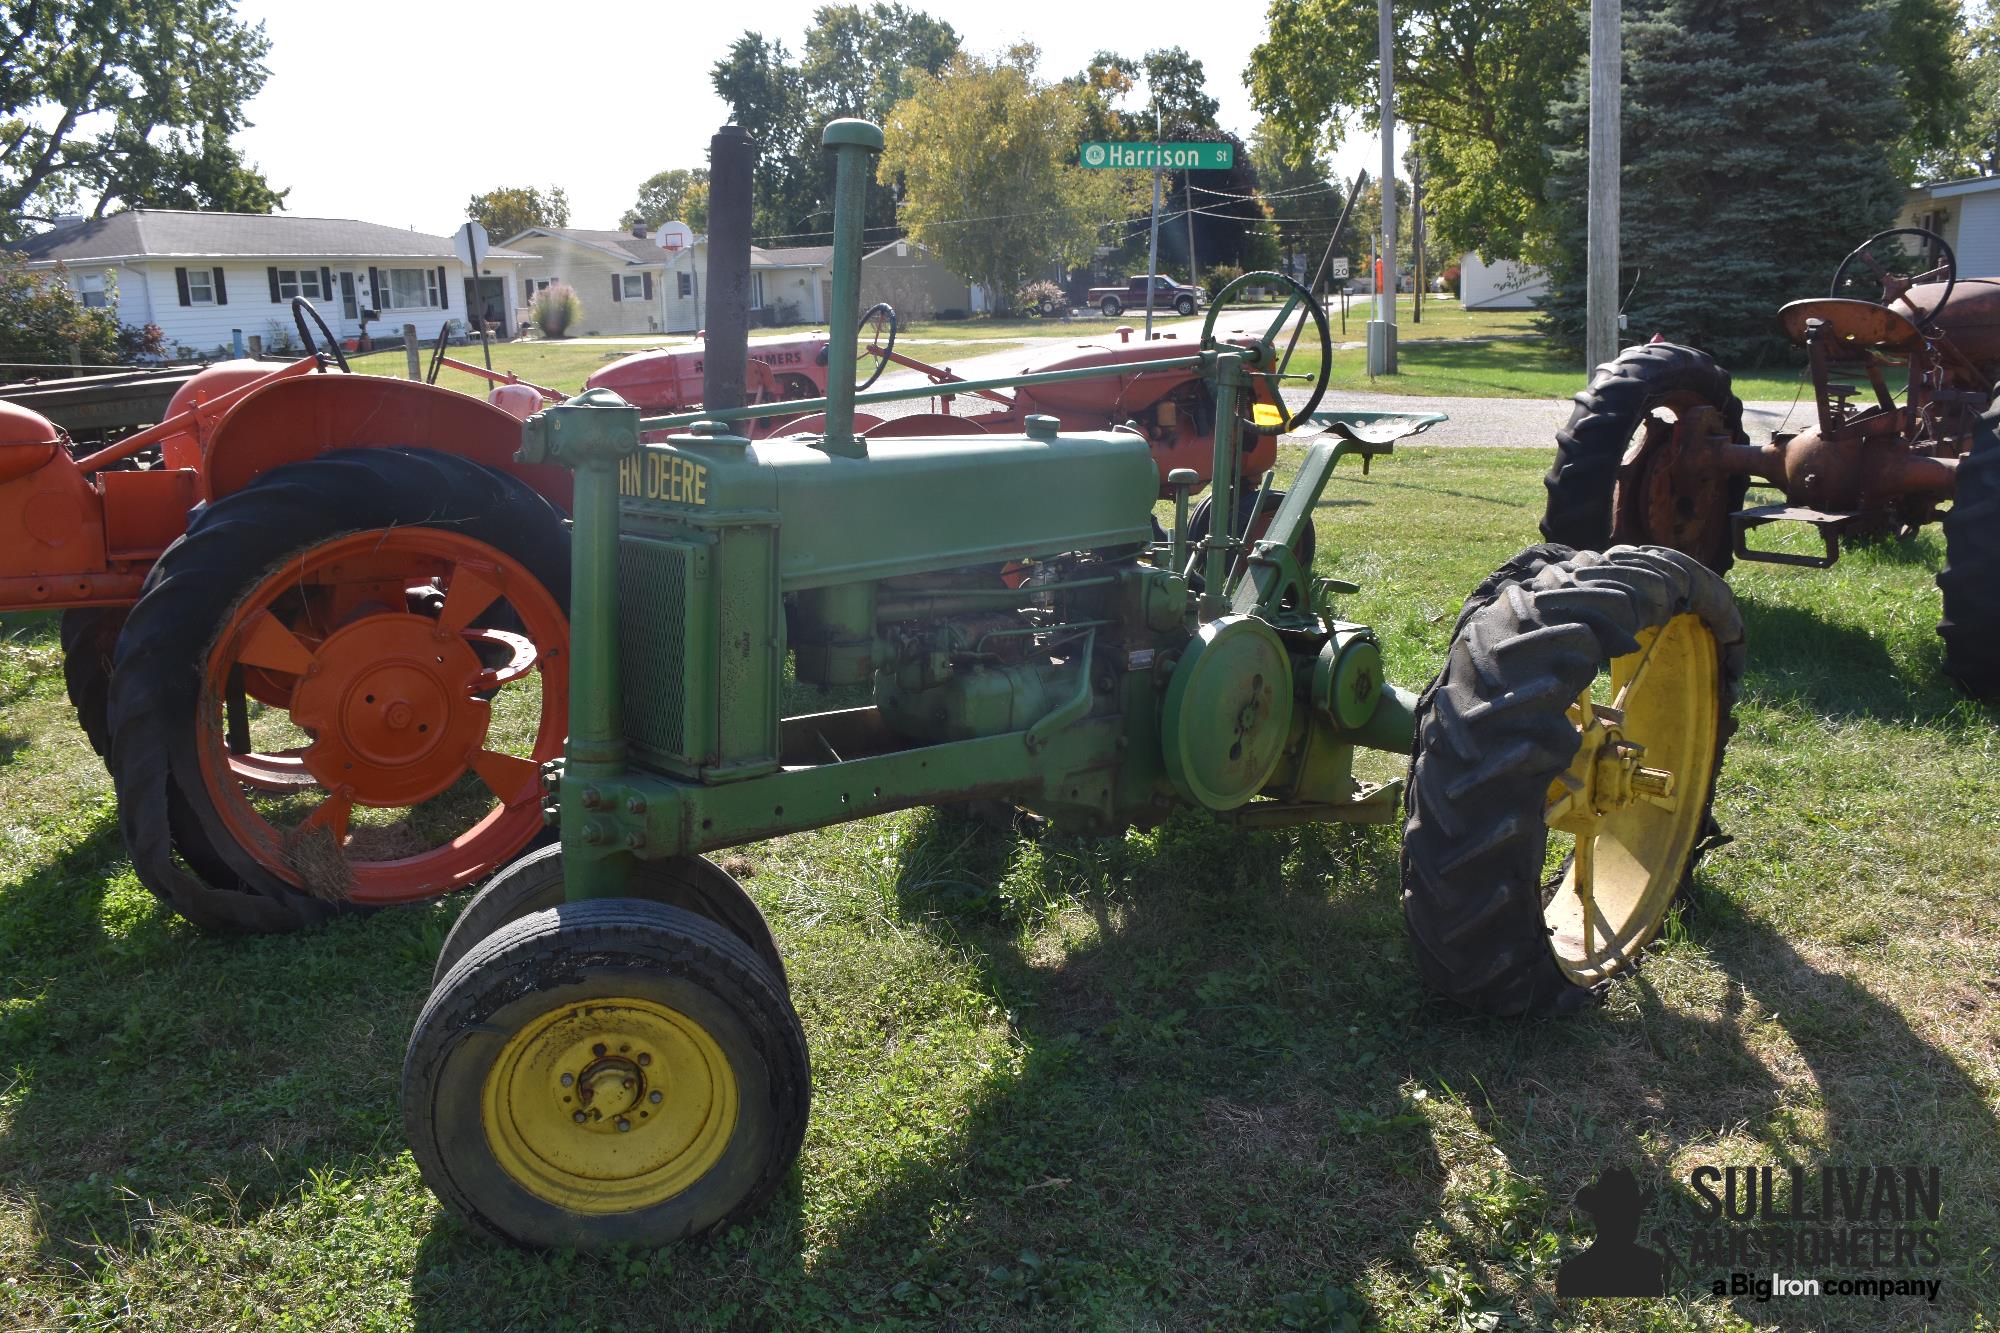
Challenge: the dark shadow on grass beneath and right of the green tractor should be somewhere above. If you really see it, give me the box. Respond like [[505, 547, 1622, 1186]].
[[780, 813, 2000, 1327]]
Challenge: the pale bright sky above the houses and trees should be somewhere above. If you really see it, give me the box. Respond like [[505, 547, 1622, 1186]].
[[236, 0, 1382, 236]]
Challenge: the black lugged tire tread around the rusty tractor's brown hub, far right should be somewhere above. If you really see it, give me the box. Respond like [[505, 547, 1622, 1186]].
[[1542, 342, 1750, 574]]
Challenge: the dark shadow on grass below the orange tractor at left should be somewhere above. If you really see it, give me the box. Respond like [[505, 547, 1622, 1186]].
[[0, 809, 452, 1271]]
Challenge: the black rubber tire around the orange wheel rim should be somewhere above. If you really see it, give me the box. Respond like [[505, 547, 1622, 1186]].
[[106, 448, 570, 935]]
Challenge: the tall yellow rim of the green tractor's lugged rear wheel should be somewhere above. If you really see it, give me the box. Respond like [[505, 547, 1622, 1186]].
[[1542, 612, 1722, 985]]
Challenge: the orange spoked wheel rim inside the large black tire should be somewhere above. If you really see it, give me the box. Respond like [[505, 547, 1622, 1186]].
[[196, 528, 568, 905]]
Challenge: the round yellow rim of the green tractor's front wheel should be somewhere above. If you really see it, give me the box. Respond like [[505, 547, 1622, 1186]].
[[480, 999, 738, 1213]]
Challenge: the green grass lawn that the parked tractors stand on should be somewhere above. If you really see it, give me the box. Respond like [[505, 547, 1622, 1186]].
[[0, 446, 2000, 1331]]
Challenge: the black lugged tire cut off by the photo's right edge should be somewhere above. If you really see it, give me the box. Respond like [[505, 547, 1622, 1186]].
[[1938, 402, 2000, 699]]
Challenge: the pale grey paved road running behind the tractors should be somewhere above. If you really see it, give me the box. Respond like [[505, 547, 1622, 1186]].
[[876, 318, 1812, 448]]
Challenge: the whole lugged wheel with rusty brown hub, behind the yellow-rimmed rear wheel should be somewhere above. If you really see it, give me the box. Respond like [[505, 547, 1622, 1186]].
[[1542, 342, 1750, 574]]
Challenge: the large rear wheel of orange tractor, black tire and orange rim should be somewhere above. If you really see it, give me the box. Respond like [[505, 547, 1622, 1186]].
[[108, 448, 570, 933]]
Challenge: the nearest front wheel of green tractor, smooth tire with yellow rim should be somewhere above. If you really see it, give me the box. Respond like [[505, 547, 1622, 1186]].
[[402, 899, 812, 1249]]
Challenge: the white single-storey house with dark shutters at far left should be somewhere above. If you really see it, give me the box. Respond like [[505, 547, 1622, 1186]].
[[10, 208, 528, 354]]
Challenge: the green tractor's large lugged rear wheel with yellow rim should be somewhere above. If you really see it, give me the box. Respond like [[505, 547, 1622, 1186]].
[[1402, 546, 1744, 1015]]
